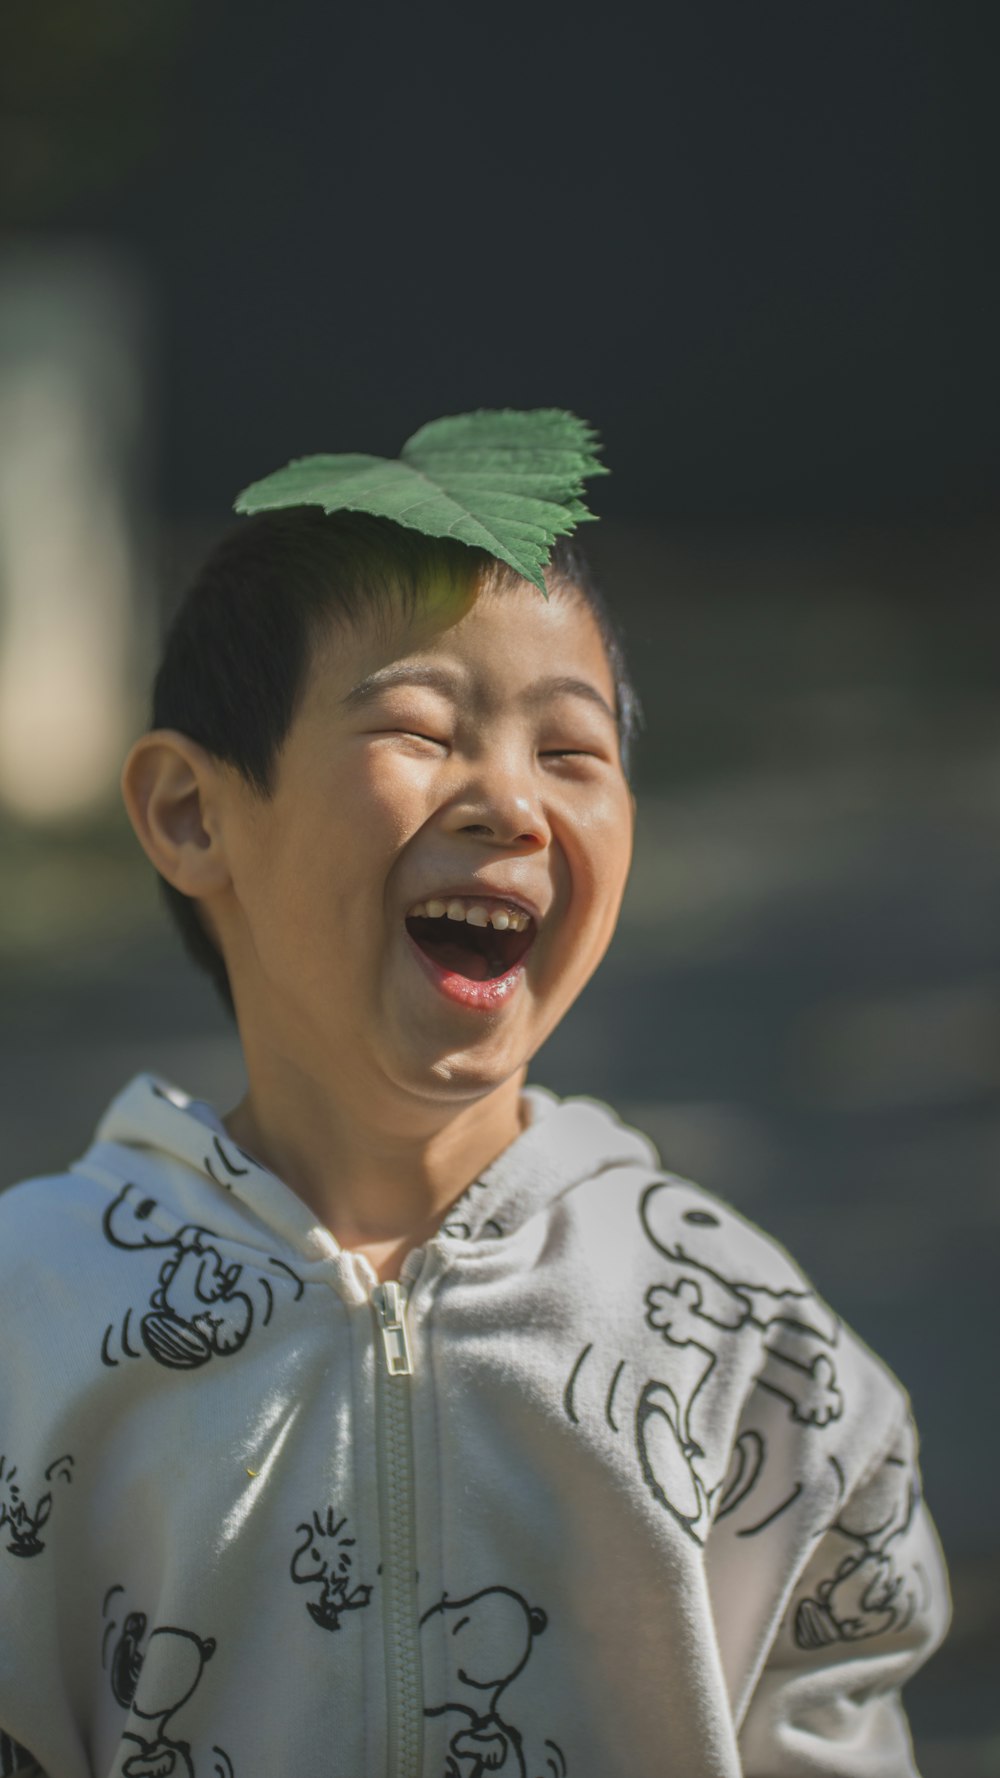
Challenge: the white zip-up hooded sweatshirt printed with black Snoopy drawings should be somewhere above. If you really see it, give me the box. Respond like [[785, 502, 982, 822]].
[[0, 1076, 948, 1778]]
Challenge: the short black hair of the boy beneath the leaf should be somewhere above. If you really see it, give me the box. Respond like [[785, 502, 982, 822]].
[[151, 507, 642, 1019]]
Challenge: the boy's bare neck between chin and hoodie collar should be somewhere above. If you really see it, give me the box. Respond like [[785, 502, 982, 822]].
[[222, 1054, 527, 1280]]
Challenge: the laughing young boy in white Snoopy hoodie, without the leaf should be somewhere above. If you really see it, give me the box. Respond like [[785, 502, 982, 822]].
[[0, 448, 948, 1778]]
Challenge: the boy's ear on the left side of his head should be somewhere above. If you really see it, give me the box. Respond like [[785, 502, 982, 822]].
[[121, 729, 230, 898]]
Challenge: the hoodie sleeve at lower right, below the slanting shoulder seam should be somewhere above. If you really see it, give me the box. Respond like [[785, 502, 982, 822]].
[[740, 1414, 950, 1778]]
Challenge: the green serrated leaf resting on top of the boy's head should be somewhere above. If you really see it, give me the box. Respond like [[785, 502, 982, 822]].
[[235, 407, 609, 592]]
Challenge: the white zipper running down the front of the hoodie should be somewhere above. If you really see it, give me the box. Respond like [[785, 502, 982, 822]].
[[370, 1284, 423, 1778]]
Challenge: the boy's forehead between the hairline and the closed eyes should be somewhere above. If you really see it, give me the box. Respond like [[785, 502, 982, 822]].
[[308, 581, 616, 717]]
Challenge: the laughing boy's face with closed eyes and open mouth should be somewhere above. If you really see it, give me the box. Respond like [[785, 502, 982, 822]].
[[215, 581, 633, 1101]]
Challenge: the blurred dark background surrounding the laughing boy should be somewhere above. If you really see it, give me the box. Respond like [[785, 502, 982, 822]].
[[0, 0, 1000, 1778]]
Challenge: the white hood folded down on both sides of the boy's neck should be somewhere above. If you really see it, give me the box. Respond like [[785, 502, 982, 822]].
[[73, 1074, 660, 1261]]
